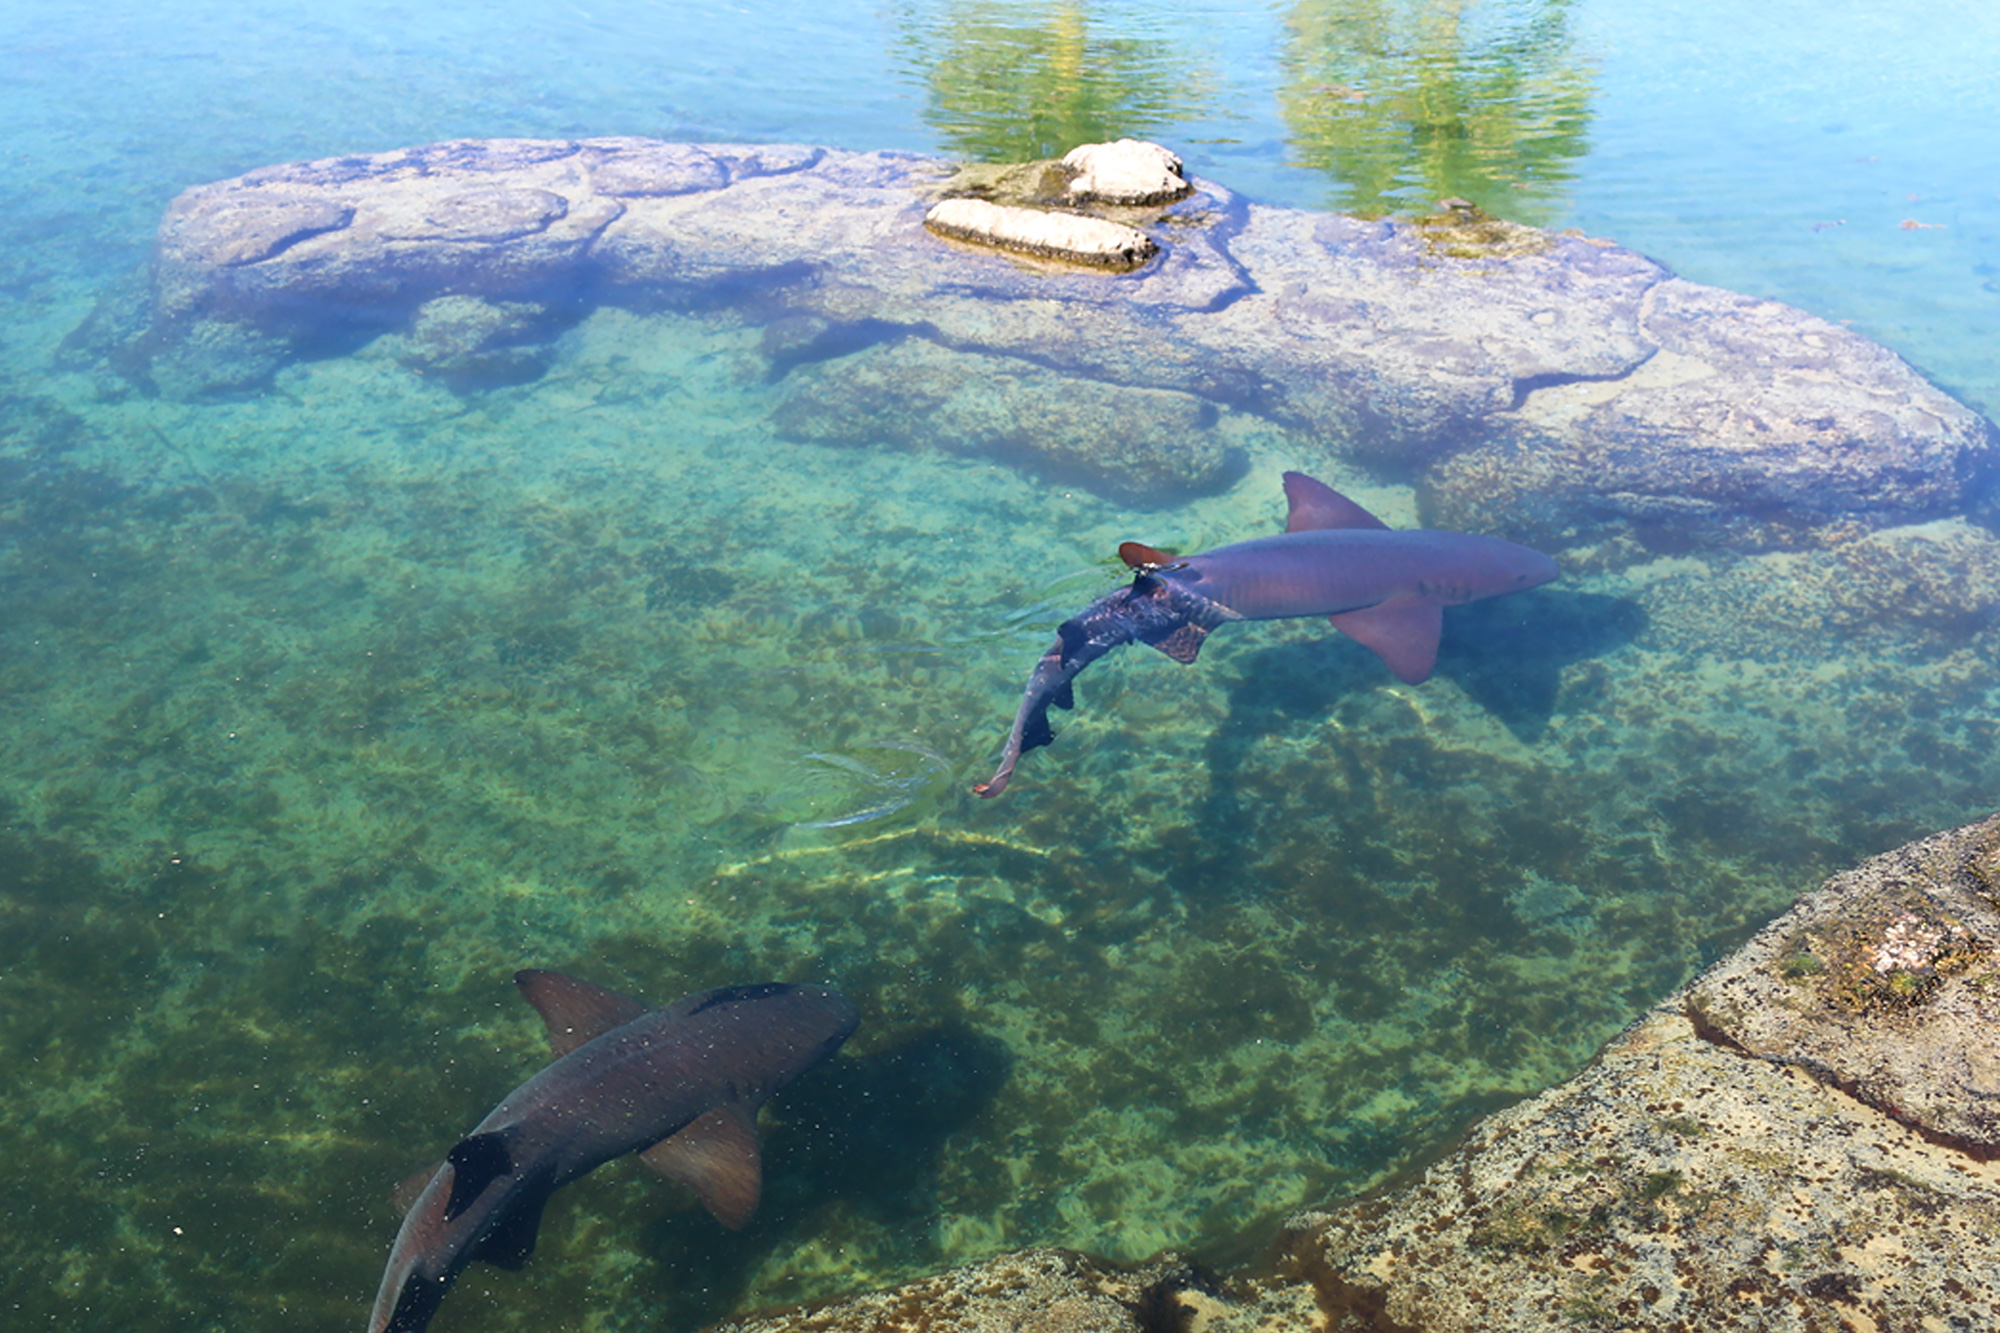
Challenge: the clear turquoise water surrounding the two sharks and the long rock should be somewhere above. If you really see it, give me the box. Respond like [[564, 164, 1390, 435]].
[[0, 2, 2000, 1329]]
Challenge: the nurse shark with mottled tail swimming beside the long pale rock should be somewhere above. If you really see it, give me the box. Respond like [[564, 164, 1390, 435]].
[[972, 472, 1560, 797]]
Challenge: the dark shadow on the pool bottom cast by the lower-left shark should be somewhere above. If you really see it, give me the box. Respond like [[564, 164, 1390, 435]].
[[648, 1023, 1014, 1333]]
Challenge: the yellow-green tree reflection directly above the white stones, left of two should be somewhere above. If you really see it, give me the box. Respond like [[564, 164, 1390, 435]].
[[900, 0, 1216, 162]]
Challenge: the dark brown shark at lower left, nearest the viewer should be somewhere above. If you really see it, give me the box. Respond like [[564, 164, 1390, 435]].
[[368, 971, 860, 1333]]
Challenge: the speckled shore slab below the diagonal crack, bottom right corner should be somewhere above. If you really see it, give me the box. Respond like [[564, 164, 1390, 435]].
[[1250, 996, 2000, 1333]]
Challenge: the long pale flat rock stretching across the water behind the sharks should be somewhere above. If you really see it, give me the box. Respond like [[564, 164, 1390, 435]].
[[101, 138, 2000, 554]]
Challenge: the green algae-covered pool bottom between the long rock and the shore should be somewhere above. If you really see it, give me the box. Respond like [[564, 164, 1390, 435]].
[[11, 298, 1996, 1329]]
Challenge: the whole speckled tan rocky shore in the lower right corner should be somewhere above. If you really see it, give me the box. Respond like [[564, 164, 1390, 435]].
[[718, 817, 2000, 1333]]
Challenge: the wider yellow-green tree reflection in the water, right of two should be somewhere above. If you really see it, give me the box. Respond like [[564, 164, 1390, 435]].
[[1278, 0, 1594, 222]]
